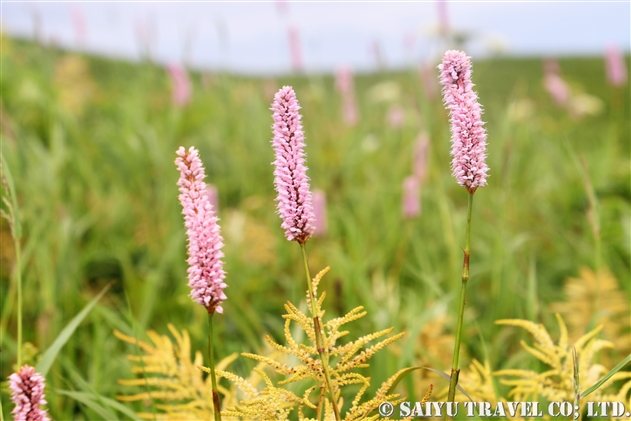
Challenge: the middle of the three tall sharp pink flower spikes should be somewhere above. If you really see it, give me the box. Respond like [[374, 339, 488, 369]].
[[271, 86, 315, 244]]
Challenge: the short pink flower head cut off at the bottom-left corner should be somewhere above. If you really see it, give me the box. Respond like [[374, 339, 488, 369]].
[[9, 365, 50, 421]]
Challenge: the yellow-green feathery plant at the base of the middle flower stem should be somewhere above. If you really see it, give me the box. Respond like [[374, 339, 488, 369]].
[[203, 267, 404, 421]]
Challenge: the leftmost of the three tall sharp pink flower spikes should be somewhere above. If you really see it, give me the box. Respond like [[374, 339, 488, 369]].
[[175, 147, 227, 314]]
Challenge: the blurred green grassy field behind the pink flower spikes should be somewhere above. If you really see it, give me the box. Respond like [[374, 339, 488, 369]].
[[0, 38, 631, 420]]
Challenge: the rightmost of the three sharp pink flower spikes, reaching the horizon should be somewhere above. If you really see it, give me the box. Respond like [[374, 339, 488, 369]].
[[438, 50, 489, 194]]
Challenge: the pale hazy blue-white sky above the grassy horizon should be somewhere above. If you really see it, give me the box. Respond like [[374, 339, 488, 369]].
[[0, 0, 631, 74]]
